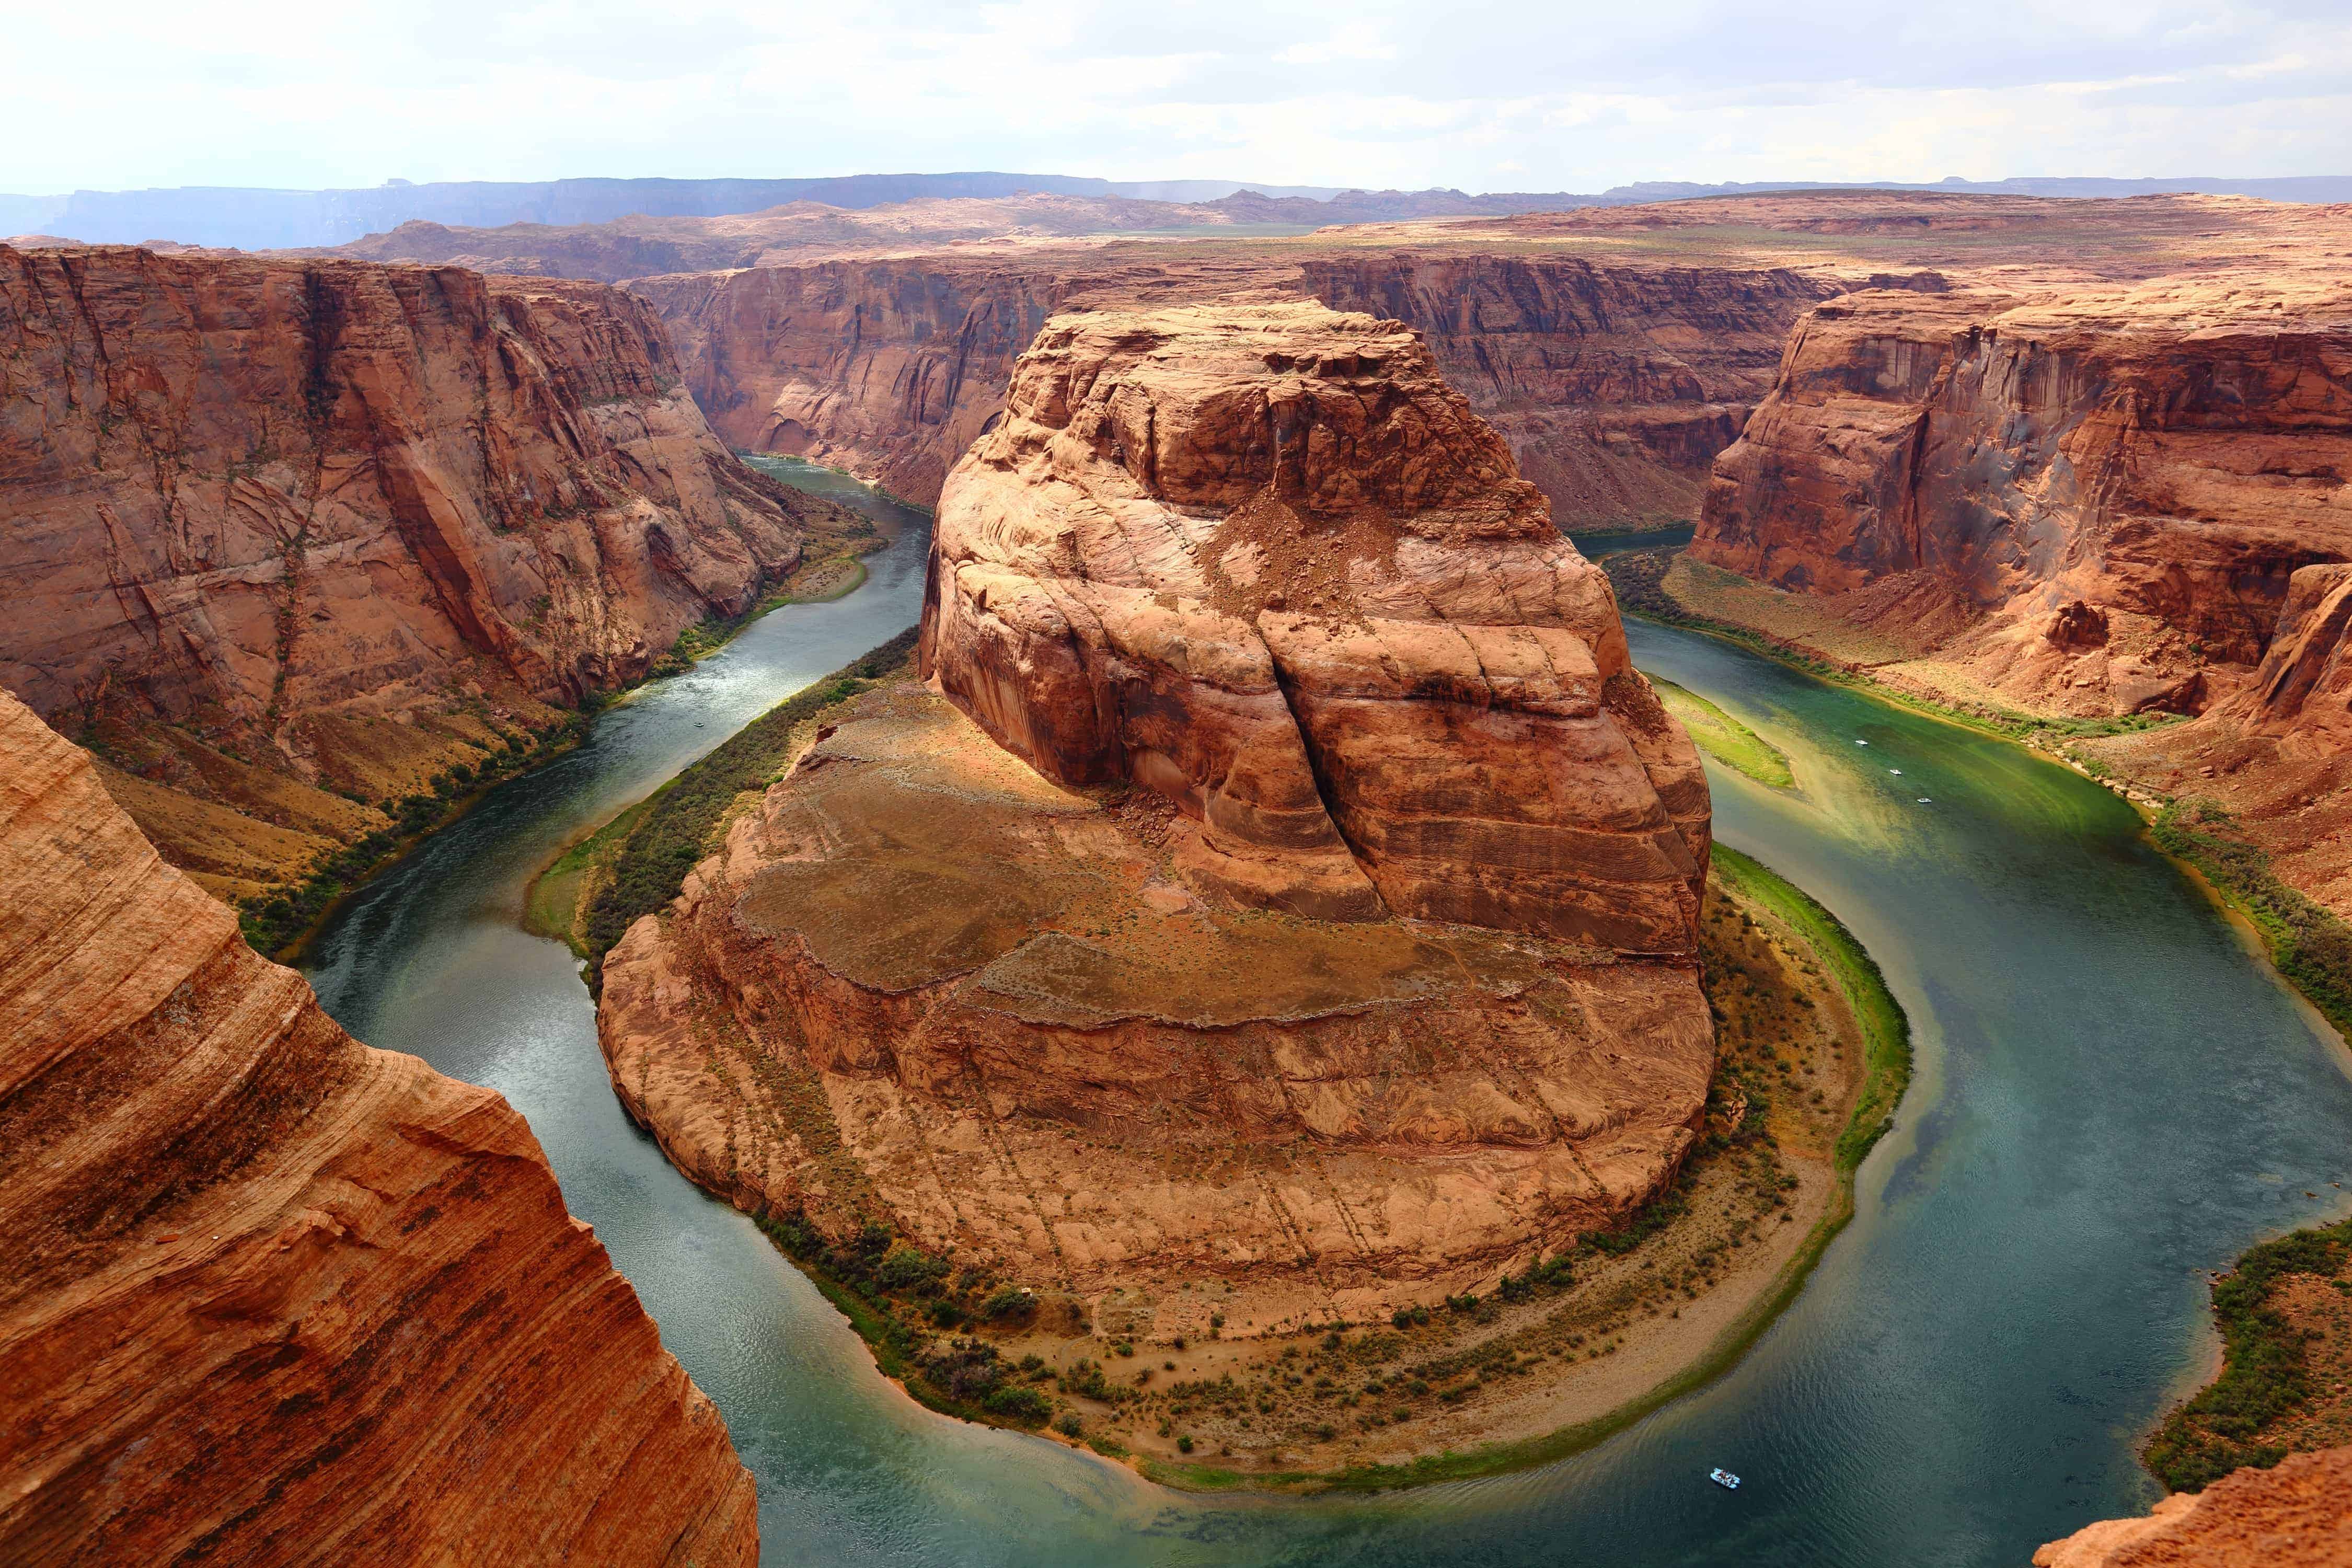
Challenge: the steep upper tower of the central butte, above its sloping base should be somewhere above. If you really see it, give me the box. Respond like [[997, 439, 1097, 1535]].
[[922, 306, 1708, 952]]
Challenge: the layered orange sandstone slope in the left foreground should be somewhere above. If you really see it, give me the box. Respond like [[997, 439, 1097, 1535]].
[[0, 694, 757, 1566]]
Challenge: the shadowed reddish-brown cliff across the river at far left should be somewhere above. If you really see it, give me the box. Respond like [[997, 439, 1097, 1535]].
[[0, 247, 833, 893]]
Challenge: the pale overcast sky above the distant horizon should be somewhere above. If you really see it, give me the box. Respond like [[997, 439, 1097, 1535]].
[[0, 0, 2352, 193]]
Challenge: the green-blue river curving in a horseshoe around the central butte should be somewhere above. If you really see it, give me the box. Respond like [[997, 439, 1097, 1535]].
[[310, 479, 2352, 1568]]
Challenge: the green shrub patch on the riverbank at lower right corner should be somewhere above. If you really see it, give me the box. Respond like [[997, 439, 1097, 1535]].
[[2140, 1220, 2352, 1493]]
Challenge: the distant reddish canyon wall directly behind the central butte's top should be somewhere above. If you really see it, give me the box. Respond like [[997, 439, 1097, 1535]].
[[628, 242, 1837, 526]]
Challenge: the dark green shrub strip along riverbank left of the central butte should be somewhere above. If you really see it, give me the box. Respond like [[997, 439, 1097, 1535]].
[[579, 628, 915, 983]]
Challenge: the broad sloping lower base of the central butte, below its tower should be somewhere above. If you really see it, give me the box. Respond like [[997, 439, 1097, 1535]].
[[597, 679, 1715, 1338]]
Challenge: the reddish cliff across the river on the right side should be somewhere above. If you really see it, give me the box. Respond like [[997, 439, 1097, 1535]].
[[1691, 273, 2352, 712]]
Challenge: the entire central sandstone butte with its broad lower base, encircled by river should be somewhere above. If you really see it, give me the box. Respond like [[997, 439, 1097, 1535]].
[[600, 303, 1715, 1338]]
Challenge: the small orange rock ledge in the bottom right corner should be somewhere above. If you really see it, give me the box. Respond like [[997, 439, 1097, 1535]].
[[2035, 1448, 2352, 1568]]
